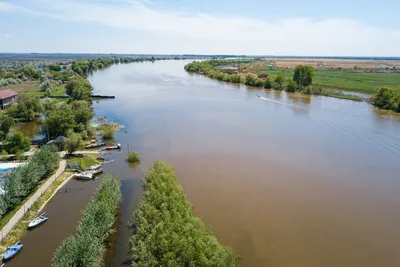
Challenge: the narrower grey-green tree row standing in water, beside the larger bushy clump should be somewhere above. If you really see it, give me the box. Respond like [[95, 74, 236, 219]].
[[52, 174, 122, 267]]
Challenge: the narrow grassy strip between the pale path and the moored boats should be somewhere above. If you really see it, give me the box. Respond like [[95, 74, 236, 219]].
[[0, 172, 72, 253]]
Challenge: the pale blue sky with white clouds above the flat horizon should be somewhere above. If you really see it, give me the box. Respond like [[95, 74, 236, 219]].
[[0, 0, 400, 56]]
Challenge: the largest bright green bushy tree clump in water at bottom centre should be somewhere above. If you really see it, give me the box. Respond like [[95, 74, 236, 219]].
[[130, 161, 239, 267]]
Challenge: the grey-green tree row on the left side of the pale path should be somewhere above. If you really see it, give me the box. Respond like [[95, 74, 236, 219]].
[[0, 145, 60, 217]]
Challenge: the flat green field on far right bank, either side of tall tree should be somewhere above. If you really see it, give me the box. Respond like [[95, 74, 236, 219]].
[[257, 69, 400, 94]]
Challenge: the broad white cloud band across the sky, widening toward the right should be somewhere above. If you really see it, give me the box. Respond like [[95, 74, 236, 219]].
[[0, 0, 400, 56]]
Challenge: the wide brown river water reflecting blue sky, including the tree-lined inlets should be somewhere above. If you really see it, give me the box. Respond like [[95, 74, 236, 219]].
[[7, 61, 400, 267]]
